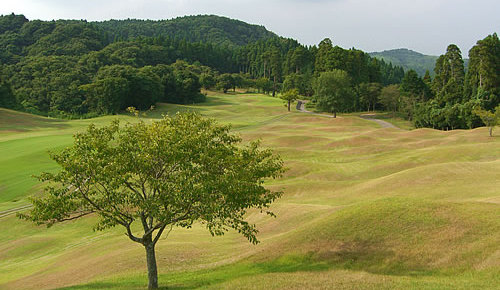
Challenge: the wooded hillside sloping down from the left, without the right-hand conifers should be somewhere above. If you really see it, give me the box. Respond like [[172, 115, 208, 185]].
[[0, 14, 404, 117]]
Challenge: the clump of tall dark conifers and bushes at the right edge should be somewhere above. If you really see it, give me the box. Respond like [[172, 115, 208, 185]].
[[374, 33, 500, 130]]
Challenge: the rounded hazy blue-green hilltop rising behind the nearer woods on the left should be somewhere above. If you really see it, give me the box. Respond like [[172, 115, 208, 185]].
[[93, 15, 278, 46]]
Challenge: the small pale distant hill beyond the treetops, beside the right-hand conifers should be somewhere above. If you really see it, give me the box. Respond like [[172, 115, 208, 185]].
[[370, 48, 438, 76]]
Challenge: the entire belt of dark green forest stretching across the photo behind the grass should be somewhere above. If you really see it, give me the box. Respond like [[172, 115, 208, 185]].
[[0, 14, 500, 129]]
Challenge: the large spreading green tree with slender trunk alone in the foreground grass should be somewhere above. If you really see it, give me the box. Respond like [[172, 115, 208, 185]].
[[20, 113, 284, 288]]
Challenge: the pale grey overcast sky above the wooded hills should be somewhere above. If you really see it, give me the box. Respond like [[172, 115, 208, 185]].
[[0, 0, 500, 55]]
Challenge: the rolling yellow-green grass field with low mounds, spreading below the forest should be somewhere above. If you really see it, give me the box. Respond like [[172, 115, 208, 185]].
[[0, 94, 500, 289]]
